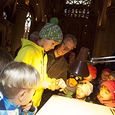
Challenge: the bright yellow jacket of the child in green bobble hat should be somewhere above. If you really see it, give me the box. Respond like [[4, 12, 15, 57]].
[[15, 39, 52, 107]]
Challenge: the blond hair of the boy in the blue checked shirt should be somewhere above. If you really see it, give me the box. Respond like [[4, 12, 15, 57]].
[[0, 62, 40, 98]]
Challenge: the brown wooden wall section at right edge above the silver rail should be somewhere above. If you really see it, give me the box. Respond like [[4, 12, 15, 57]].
[[93, 0, 115, 56]]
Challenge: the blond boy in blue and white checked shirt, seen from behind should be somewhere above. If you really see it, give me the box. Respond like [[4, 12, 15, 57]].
[[0, 62, 40, 115]]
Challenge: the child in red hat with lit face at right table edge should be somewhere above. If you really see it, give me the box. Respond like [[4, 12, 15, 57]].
[[97, 80, 115, 107]]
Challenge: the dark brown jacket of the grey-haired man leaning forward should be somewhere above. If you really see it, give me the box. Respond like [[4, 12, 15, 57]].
[[47, 51, 69, 80]]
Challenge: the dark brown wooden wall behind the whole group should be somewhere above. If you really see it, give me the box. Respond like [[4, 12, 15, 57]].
[[0, 0, 115, 56]]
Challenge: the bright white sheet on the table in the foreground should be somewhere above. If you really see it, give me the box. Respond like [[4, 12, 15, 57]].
[[37, 95, 113, 115]]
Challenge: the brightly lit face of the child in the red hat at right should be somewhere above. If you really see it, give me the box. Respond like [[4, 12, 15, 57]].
[[98, 86, 112, 100]]
